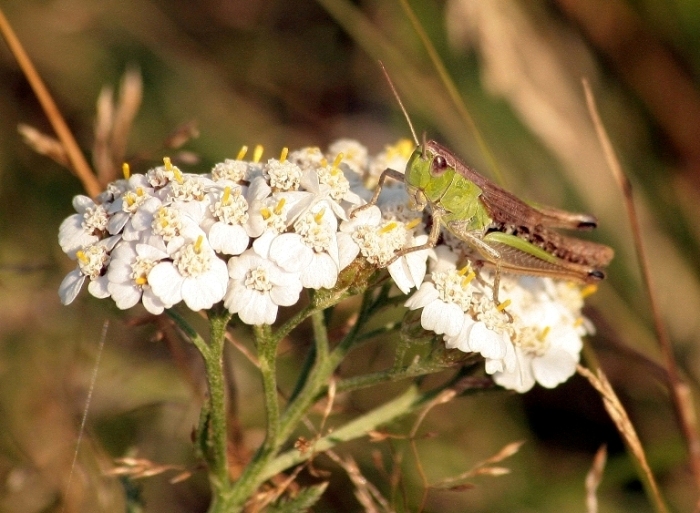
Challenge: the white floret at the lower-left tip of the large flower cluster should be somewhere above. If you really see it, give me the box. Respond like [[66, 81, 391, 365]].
[[58, 237, 119, 305]]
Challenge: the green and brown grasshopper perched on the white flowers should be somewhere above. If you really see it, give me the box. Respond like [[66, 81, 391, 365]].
[[353, 71, 614, 304]]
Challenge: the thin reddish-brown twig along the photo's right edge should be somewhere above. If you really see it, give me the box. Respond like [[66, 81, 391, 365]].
[[583, 79, 700, 492]]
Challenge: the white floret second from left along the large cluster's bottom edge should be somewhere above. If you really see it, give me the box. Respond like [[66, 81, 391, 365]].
[[106, 239, 172, 315]]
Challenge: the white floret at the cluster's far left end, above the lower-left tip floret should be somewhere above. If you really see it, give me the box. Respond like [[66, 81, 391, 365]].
[[58, 196, 109, 258]]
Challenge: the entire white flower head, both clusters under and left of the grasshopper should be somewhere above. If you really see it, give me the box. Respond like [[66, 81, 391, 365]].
[[59, 140, 592, 392]]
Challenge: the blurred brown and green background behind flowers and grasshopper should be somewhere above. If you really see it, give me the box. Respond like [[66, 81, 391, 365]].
[[0, 0, 700, 512]]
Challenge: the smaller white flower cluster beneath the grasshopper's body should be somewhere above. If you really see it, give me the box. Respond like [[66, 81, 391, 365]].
[[406, 245, 593, 392]]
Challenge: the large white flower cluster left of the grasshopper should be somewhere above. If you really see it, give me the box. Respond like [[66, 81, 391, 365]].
[[59, 140, 427, 325]]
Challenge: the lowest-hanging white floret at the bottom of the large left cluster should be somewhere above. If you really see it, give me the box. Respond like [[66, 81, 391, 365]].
[[224, 249, 302, 325]]
